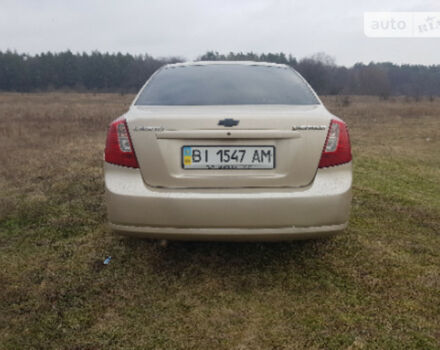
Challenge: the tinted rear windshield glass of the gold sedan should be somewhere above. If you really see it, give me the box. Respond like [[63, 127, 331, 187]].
[[135, 64, 319, 105]]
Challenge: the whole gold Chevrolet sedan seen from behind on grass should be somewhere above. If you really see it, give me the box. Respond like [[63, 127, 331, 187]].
[[104, 62, 352, 241]]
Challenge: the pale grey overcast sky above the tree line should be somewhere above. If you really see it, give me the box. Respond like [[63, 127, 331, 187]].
[[0, 0, 440, 65]]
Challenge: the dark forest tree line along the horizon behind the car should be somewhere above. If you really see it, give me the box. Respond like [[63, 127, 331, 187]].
[[0, 51, 440, 98]]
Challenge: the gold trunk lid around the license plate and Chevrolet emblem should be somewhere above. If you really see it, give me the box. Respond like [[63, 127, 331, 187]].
[[126, 105, 332, 188]]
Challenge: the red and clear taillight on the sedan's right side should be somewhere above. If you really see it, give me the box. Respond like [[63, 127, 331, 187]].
[[319, 120, 351, 168]]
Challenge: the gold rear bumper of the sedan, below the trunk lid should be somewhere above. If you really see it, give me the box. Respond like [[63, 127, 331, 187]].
[[105, 163, 352, 240]]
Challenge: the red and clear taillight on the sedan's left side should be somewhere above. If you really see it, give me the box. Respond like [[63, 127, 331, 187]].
[[105, 119, 139, 168]]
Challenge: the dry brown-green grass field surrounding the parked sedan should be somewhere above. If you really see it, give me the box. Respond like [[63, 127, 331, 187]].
[[0, 93, 440, 350]]
